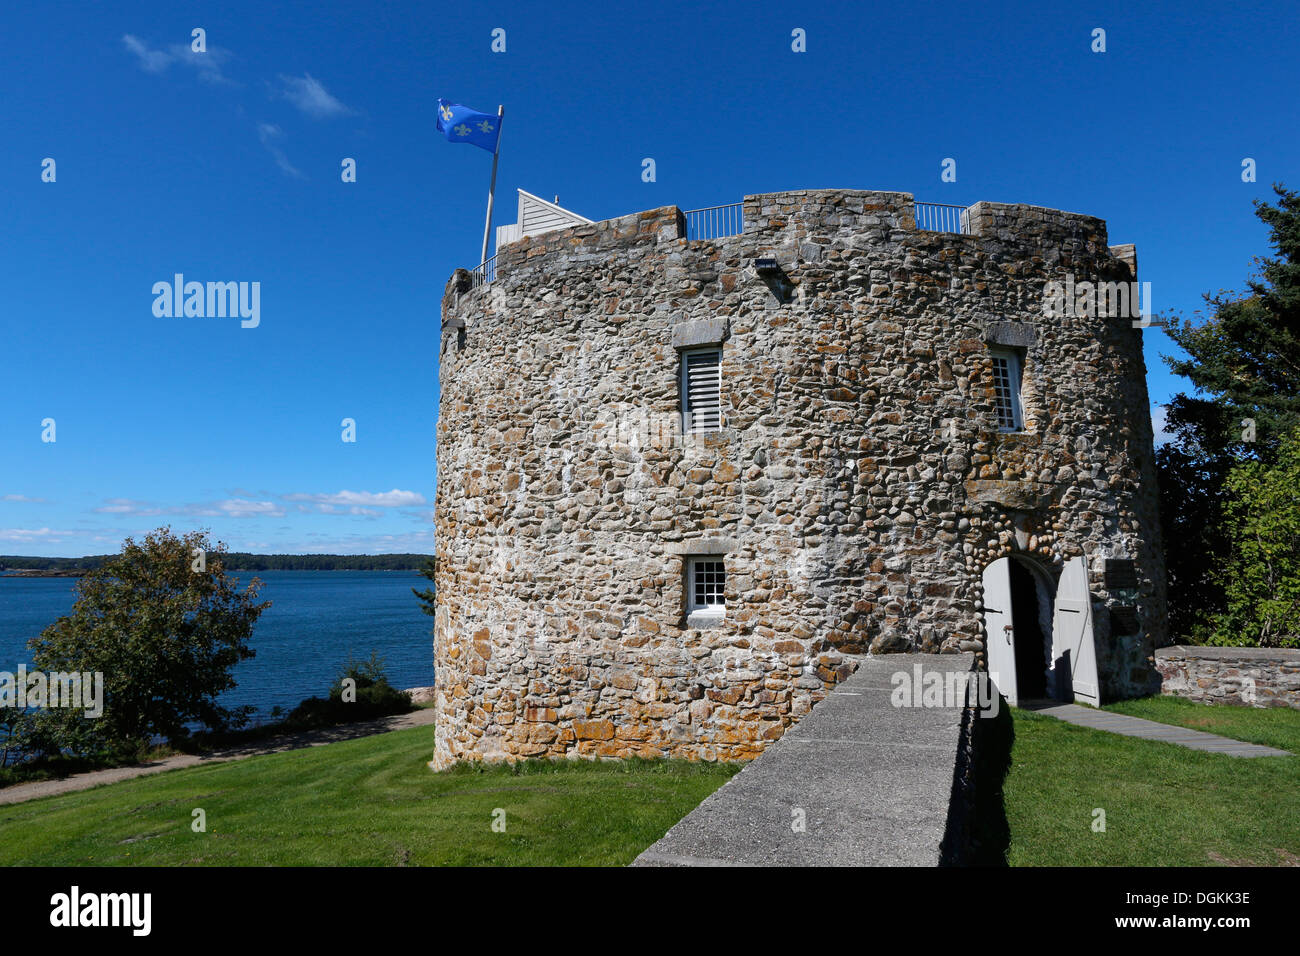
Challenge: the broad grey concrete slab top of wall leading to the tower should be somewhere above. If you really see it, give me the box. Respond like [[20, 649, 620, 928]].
[[632, 654, 974, 866]]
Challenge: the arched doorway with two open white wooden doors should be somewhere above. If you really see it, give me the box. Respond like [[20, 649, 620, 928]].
[[984, 554, 1100, 706]]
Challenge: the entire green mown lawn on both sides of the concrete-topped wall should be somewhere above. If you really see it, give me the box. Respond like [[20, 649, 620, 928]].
[[0, 700, 1300, 866]]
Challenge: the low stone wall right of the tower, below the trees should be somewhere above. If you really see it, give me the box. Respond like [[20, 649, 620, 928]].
[[1156, 644, 1300, 710]]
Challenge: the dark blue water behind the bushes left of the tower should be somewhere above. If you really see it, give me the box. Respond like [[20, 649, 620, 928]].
[[0, 571, 433, 719]]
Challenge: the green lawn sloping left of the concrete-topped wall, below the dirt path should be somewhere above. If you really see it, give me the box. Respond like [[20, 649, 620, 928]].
[[0, 726, 738, 866]]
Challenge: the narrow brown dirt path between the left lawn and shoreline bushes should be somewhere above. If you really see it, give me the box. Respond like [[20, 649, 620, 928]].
[[0, 708, 434, 805]]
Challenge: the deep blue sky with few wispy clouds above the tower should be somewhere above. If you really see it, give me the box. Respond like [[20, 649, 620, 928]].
[[0, 0, 1300, 555]]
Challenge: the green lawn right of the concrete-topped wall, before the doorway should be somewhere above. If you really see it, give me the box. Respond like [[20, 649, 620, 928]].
[[1005, 700, 1300, 866]]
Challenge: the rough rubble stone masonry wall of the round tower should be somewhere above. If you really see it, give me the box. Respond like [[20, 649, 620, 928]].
[[433, 190, 1165, 767]]
